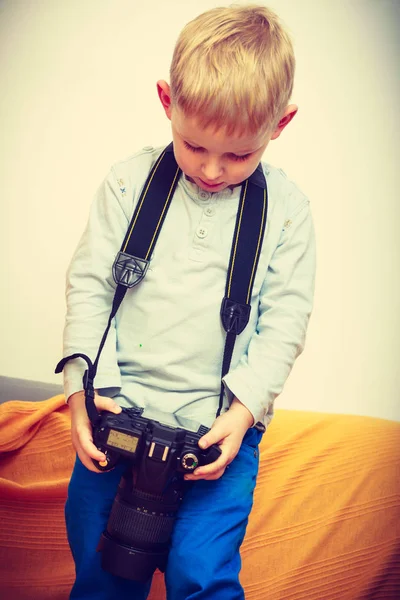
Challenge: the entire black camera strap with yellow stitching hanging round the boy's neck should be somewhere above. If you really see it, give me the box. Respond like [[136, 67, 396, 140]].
[[55, 144, 268, 425]]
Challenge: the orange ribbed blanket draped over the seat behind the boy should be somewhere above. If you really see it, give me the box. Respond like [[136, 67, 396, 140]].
[[0, 396, 400, 600]]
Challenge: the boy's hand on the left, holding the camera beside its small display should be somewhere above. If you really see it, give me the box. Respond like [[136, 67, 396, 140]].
[[68, 390, 122, 473]]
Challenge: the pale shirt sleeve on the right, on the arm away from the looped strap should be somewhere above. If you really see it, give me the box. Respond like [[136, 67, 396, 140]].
[[223, 199, 316, 425]]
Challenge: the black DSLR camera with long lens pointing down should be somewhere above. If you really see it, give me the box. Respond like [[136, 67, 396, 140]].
[[93, 408, 221, 582]]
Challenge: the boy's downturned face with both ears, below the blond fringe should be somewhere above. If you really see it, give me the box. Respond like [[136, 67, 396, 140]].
[[158, 82, 297, 192]]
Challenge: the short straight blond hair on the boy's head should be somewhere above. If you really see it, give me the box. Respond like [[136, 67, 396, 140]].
[[170, 4, 295, 135]]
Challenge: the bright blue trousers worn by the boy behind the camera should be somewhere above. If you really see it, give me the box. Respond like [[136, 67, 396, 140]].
[[65, 428, 262, 600]]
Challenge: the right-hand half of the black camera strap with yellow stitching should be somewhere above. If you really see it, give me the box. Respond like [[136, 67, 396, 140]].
[[217, 180, 268, 417]]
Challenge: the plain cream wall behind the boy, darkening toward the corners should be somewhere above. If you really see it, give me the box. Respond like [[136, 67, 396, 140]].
[[0, 0, 400, 420]]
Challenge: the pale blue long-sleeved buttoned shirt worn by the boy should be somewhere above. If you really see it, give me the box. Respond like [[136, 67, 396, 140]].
[[64, 147, 315, 434]]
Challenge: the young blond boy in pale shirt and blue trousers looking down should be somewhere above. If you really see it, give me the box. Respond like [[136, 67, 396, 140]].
[[60, 6, 315, 600]]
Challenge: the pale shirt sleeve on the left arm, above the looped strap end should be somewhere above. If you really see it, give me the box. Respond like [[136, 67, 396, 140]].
[[63, 170, 129, 400]]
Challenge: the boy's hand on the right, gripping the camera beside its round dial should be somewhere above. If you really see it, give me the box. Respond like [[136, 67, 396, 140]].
[[185, 398, 254, 481]]
